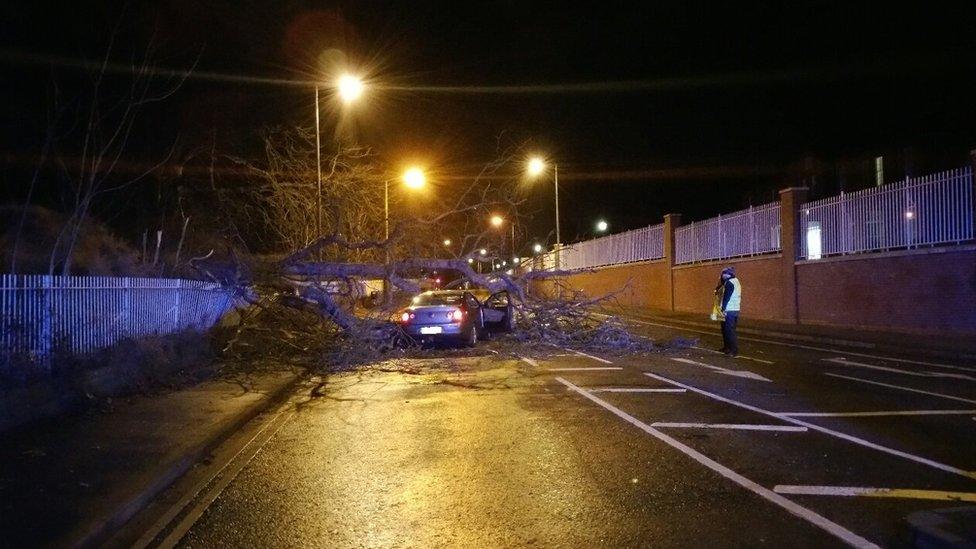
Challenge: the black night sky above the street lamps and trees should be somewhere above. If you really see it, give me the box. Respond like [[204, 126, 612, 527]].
[[0, 0, 976, 248]]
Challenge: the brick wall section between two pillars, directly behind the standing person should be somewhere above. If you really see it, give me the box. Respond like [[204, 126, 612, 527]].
[[674, 256, 790, 320]]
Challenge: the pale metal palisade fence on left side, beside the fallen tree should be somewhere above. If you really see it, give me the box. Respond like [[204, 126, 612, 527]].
[[0, 275, 233, 359]]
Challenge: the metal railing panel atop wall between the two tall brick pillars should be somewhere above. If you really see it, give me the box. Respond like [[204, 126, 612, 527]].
[[674, 202, 781, 264]]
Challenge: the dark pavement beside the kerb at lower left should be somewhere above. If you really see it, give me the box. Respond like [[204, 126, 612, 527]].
[[0, 371, 297, 547]]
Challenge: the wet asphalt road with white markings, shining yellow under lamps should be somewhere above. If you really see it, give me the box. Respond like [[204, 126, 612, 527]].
[[149, 318, 976, 547]]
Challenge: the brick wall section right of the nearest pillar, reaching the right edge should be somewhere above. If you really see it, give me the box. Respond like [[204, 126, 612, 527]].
[[797, 248, 976, 333]]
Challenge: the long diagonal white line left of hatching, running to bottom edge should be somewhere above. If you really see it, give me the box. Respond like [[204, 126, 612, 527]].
[[556, 377, 877, 547]]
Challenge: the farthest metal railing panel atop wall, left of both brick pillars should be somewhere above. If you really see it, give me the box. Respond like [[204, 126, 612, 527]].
[[559, 224, 664, 270]]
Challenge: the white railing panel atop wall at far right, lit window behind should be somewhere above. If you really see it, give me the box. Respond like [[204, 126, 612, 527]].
[[800, 168, 973, 259]]
